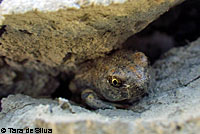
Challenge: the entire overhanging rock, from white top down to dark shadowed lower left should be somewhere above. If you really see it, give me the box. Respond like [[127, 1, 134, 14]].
[[0, 0, 183, 97]]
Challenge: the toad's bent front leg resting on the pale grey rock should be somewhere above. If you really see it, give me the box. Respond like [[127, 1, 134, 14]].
[[81, 89, 115, 109]]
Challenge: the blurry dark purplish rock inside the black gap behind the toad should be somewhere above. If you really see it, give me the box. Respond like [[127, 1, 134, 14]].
[[124, 31, 176, 62]]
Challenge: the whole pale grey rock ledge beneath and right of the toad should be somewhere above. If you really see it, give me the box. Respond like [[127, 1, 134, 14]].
[[0, 38, 200, 134]]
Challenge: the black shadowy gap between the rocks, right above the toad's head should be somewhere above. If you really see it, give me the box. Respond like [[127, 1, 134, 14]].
[[124, 0, 200, 64]]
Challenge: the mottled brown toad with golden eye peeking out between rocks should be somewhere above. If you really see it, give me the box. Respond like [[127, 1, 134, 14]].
[[70, 50, 149, 109]]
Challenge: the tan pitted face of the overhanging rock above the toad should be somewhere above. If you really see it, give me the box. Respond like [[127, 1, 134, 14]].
[[0, 0, 183, 66]]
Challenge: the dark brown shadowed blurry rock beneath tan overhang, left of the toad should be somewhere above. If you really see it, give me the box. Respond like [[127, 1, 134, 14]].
[[0, 56, 59, 98]]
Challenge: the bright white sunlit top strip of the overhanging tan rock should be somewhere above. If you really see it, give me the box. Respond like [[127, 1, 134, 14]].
[[0, 0, 127, 15]]
